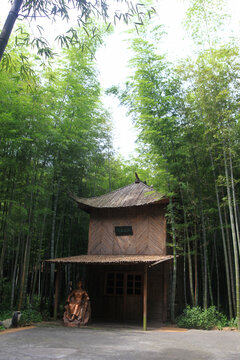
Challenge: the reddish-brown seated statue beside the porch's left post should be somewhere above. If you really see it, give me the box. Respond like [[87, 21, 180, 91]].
[[63, 280, 91, 327]]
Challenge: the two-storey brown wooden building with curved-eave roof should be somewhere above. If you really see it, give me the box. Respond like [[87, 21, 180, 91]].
[[50, 177, 172, 328]]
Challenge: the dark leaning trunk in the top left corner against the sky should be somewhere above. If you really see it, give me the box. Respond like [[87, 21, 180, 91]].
[[0, 0, 23, 61]]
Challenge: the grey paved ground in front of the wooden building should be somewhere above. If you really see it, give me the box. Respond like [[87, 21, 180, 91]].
[[0, 327, 240, 360]]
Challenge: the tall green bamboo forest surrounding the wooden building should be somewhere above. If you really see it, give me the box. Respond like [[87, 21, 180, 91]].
[[0, 0, 240, 329]]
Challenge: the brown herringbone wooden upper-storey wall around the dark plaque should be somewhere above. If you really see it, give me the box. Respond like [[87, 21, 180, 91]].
[[88, 206, 166, 255]]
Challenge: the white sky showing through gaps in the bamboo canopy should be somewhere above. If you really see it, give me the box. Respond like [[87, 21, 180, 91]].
[[0, 0, 240, 159]]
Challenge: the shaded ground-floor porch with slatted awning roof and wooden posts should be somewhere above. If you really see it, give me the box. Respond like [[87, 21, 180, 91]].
[[48, 255, 172, 330]]
